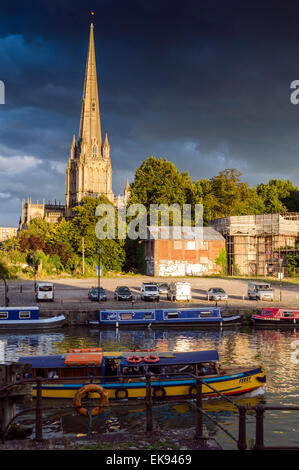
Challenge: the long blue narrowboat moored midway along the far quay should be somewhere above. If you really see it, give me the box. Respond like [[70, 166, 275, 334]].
[[89, 307, 242, 328]]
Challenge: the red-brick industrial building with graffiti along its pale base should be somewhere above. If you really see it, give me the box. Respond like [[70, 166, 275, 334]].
[[145, 227, 225, 277]]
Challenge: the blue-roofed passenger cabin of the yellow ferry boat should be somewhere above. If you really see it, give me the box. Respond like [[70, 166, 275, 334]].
[[19, 348, 219, 383]]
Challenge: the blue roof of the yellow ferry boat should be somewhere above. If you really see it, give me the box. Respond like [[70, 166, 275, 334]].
[[19, 350, 219, 369]]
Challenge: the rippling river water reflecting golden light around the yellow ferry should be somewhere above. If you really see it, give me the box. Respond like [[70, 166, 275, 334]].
[[0, 327, 299, 449]]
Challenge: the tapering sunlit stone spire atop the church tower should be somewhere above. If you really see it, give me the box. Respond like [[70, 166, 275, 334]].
[[78, 23, 102, 157]]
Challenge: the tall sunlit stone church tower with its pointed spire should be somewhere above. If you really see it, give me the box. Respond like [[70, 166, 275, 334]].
[[65, 23, 114, 219]]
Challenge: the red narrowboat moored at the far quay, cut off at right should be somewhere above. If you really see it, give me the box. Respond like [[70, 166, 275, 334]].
[[251, 308, 299, 328]]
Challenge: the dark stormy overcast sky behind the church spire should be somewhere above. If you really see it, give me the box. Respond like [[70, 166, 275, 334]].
[[0, 0, 299, 225]]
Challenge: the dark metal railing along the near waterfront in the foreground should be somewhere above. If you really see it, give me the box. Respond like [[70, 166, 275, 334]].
[[0, 374, 292, 450]]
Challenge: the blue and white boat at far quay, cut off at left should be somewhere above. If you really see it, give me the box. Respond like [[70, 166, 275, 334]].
[[0, 306, 66, 331]]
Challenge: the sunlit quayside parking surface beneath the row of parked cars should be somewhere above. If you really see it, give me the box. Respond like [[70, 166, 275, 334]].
[[0, 276, 299, 310]]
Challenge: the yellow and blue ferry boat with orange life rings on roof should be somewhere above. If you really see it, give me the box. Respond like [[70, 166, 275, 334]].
[[19, 348, 266, 400]]
